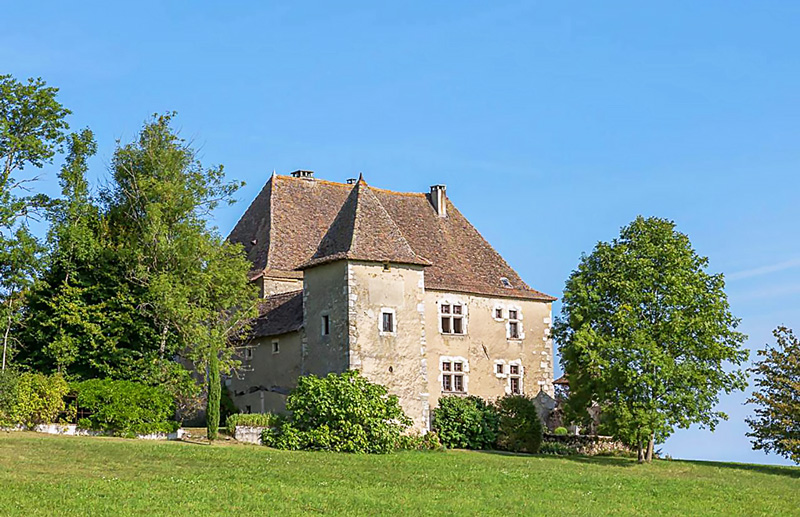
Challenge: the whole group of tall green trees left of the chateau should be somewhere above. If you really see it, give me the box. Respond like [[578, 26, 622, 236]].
[[0, 75, 257, 433]]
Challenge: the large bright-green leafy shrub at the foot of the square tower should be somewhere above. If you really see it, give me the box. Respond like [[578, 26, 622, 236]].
[[262, 371, 411, 453]]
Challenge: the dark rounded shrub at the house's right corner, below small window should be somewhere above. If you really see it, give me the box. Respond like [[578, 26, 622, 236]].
[[497, 395, 542, 454]]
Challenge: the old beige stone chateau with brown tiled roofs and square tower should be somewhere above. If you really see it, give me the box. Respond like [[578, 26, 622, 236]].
[[226, 171, 555, 429]]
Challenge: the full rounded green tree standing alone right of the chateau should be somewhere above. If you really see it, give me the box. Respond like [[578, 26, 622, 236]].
[[554, 217, 748, 461]]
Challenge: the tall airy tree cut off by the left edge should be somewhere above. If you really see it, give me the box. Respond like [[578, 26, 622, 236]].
[[0, 75, 69, 369]]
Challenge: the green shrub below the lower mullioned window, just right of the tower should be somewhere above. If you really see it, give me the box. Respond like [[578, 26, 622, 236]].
[[433, 395, 498, 449]]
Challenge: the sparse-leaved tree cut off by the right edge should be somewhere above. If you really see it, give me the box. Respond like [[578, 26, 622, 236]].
[[746, 327, 800, 463]]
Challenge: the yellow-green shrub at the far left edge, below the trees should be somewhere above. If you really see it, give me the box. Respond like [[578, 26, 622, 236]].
[[0, 370, 69, 427]]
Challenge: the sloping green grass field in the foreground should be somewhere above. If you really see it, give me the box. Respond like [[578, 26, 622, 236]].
[[0, 432, 800, 517]]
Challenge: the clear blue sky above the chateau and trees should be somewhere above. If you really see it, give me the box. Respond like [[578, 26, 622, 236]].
[[6, 1, 800, 463]]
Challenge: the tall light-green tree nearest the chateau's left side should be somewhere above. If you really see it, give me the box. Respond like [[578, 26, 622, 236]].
[[104, 114, 256, 428]]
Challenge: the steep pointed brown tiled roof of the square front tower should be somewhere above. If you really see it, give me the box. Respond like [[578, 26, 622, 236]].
[[300, 178, 430, 269]]
